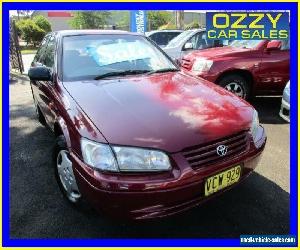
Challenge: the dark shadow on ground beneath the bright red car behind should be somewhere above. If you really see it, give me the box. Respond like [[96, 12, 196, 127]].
[[250, 96, 286, 124]]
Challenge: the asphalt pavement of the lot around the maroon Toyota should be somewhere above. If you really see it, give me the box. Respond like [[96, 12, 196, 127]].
[[9, 74, 290, 239]]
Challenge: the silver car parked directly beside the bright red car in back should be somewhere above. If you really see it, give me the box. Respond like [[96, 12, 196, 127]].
[[163, 29, 228, 60]]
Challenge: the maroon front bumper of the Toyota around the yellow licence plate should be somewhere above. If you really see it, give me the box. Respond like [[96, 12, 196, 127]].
[[71, 127, 266, 219]]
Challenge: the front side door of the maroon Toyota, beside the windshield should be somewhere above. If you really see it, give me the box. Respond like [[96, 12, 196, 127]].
[[39, 34, 56, 127]]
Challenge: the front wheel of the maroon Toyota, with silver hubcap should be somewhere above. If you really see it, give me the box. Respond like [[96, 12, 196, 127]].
[[53, 135, 82, 206]]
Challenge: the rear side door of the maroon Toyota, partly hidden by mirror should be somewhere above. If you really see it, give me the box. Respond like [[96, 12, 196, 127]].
[[30, 35, 50, 113]]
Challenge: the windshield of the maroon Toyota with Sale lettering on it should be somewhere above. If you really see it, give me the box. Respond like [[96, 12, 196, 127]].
[[63, 34, 177, 81]]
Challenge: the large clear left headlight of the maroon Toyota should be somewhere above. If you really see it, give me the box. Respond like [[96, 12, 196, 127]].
[[81, 139, 171, 172]]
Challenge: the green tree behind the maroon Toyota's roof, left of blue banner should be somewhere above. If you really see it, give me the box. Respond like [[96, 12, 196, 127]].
[[70, 11, 111, 29]]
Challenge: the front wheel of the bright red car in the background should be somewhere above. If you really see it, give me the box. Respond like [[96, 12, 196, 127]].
[[218, 74, 251, 100]]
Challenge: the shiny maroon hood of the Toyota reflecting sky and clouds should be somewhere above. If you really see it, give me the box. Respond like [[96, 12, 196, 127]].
[[64, 72, 253, 152]]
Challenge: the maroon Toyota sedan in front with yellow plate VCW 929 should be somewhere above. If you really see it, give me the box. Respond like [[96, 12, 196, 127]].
[[28, 30, 266, 219]]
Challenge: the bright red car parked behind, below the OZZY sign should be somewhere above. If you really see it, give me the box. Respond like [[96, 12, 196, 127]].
[[181, 40, 290, 99]]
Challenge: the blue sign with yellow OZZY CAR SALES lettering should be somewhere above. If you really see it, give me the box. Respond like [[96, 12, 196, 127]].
[[206, 12, 289, 40]]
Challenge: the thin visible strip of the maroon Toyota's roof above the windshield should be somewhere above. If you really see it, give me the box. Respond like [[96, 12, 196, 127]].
[[55, 29, 143, 36]]
